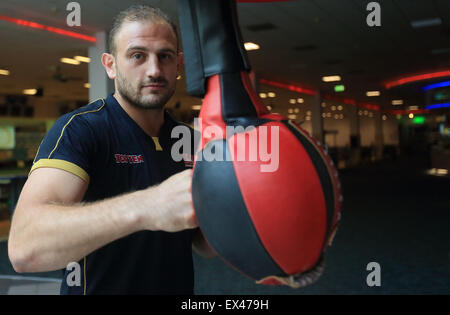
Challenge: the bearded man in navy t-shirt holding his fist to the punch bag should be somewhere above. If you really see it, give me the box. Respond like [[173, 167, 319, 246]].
[[8, 6, 214, 294]]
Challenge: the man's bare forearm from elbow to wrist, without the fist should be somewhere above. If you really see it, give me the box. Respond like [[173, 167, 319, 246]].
[[8, 188, 155, 272]]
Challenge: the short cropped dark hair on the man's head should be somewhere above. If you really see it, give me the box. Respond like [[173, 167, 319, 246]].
[[108, 5, 178, 55]]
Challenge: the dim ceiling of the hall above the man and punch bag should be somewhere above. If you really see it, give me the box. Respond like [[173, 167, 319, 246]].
[[0, 0, 450, 108]]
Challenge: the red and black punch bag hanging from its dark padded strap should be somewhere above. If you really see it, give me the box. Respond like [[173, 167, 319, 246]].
[[178, 0, 342, 287]]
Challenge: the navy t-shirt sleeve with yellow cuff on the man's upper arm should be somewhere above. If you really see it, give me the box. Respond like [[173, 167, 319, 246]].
[[30, 114, 95, 183]]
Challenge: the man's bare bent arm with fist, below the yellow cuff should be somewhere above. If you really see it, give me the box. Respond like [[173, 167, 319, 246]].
[[8, 168, 198, 272]]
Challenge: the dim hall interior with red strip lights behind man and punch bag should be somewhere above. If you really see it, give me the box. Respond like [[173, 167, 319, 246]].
[[0, 0, 450, 295]]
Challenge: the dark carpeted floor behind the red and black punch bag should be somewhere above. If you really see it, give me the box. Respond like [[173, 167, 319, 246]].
[[0, 154, 450, 295]]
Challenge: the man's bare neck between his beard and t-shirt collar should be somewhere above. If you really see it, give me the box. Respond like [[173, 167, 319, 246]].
[[113, 92, 164, 137]]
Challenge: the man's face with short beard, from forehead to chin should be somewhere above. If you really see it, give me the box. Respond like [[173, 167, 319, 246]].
[[115, 21, 179, 109]]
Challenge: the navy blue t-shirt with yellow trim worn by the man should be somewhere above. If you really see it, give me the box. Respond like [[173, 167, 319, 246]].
[[31, 95, 196, 294]]
